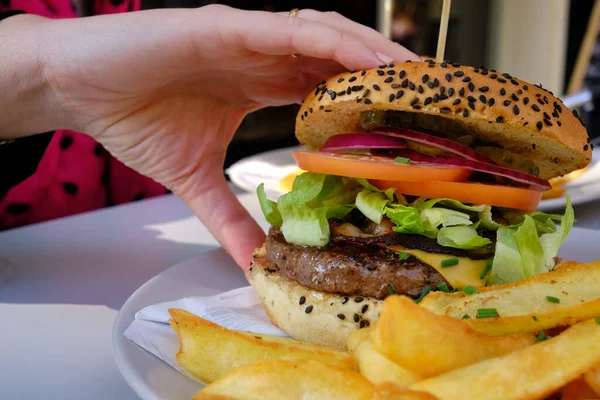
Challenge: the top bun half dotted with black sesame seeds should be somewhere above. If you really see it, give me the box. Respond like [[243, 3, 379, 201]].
[[296, 60, 592, 179]]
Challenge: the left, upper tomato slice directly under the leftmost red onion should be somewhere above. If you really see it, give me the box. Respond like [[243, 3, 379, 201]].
[[292, 150, 472, 182]]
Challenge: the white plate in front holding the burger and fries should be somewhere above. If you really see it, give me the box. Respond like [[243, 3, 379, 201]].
[[113, 228, 600, 400]]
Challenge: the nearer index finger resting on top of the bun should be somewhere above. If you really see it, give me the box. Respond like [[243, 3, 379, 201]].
[[211, 8, 396, 69]]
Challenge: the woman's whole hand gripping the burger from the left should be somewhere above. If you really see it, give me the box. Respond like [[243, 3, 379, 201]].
[[34, 6, 418, 269]]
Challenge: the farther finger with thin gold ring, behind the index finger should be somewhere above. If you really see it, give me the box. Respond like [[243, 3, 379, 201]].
[[280, 9, 420, 63]]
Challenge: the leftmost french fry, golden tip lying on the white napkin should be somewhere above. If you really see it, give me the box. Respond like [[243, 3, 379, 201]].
[[169, 309, 356, 383]]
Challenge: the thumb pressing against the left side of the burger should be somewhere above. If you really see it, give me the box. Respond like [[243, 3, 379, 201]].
[[182, 175, 265, 271]]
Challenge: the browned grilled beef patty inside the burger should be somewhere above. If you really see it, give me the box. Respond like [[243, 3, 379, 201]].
[[266, 227, 448, 299]]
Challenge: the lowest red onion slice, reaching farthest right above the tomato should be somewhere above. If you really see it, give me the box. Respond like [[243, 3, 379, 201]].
[[386, 149, 551, 191]]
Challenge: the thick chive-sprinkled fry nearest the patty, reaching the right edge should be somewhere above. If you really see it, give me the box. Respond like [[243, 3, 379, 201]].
[[420, 261, 600, 336]]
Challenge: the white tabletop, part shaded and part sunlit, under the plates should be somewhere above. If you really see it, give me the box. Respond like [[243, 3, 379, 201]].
[[0, 188, 600, 400]]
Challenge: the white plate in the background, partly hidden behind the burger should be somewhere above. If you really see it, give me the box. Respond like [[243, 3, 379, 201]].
[[225, 147, 600, 211]]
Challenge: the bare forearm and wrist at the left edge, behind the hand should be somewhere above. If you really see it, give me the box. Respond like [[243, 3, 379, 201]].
[[0, 15, 71, 140]]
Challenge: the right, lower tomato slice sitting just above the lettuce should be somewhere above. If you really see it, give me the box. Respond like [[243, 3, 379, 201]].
[[371, 180, 542, 211]]
